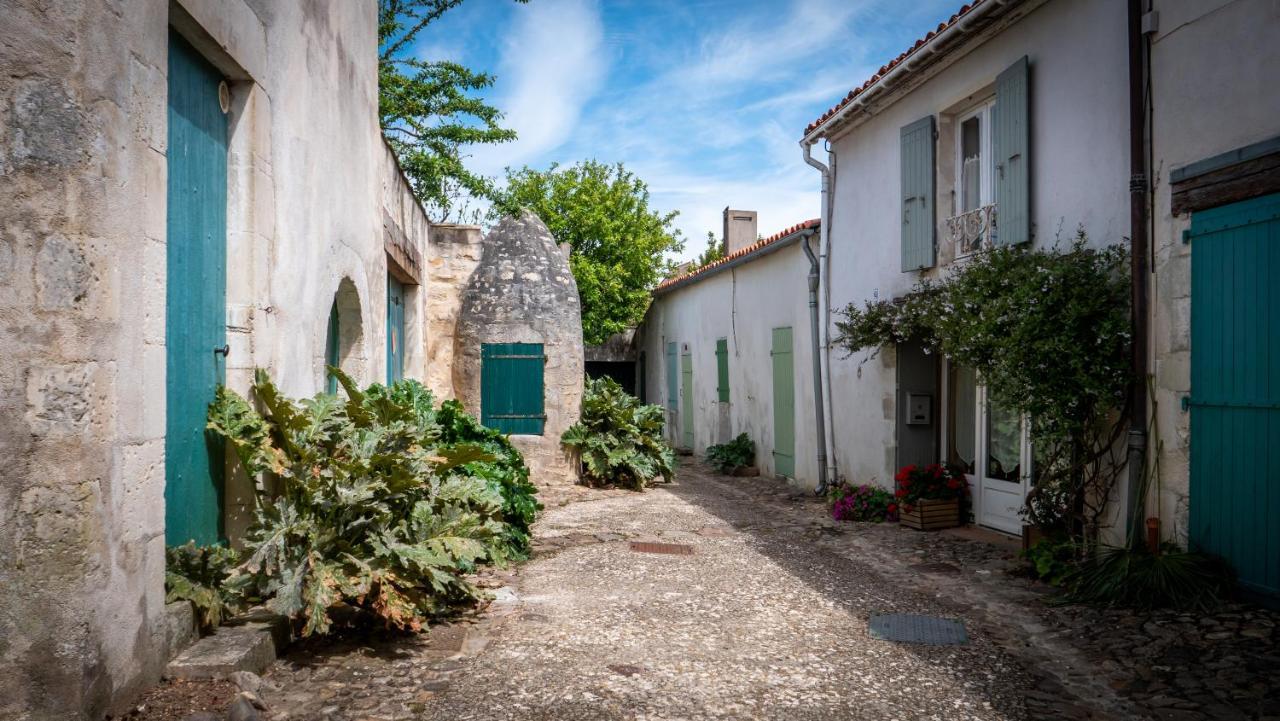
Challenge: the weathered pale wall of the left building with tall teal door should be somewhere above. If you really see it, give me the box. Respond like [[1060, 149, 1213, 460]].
[[0, 0, 428, 721]]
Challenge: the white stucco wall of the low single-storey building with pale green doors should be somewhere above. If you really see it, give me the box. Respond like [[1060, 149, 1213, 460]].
[[641, 244, 818, 487]]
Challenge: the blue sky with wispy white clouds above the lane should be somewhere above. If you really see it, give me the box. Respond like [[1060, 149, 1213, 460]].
[[413, 0, 961, 260]]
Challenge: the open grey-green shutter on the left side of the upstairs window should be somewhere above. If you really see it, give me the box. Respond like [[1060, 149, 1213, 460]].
[[901, 115, 937, 273]]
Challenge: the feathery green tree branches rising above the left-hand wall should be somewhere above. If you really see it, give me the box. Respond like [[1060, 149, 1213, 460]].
[[378, 0, 525, 220]]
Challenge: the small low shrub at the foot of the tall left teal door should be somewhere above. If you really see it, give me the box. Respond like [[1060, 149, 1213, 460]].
[[164, 542, 243, 631]]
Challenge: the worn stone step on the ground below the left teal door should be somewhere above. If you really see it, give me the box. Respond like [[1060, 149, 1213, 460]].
[[166, 608, 289, 679]]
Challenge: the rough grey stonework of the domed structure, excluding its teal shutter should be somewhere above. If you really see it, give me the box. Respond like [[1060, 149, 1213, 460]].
[[455, 211, 584, 485]]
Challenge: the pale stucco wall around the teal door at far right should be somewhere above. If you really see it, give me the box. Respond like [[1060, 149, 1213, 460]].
[[1148, 0, 1280, 542]]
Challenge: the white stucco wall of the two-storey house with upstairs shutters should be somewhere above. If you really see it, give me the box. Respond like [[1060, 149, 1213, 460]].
[[828, 0, 1129, 494]]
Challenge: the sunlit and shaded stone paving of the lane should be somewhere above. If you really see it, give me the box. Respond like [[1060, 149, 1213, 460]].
[[254, 460, 1280, 721]]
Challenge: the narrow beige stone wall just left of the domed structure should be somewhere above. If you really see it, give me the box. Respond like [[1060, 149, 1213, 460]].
[[425, 224, 481, 400]]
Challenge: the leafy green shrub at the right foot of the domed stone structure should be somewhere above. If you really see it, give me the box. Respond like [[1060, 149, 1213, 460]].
[[561, 378, 676, 490]]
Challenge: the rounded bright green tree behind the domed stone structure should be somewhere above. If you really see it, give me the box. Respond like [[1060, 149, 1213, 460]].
[[490, 160, 685, 343]]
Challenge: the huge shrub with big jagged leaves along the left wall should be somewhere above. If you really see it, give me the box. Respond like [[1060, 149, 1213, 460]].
[[209, 368, 531, 635]]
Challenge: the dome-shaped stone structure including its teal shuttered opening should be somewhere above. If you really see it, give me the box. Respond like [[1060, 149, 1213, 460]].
[[453, 210, 584, 485]]
